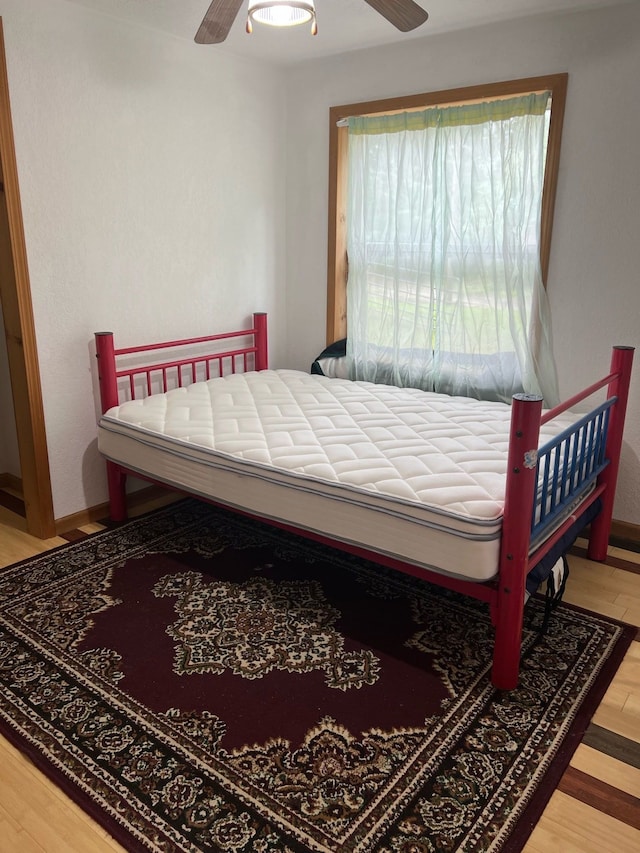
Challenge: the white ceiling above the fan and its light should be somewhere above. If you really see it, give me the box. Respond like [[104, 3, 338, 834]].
[[69, 0, 620, 65]]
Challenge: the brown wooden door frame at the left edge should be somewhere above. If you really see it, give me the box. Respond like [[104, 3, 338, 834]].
[[0, 17, 56, 539]]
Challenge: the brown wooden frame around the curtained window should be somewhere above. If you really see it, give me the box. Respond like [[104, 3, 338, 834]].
[[327, 73, 569, 344]]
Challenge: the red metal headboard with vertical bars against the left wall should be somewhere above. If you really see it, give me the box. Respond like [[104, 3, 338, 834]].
[[95, 313, 268, 413]]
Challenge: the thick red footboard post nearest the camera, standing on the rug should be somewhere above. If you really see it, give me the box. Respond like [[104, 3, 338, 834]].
[[491, 394, 542, 690]]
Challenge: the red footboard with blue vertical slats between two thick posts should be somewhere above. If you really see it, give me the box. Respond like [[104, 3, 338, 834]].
[[493, 347, 634, 690]]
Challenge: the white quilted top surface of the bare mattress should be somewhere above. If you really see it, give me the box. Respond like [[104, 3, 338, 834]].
[[102, 370, 576, 521]]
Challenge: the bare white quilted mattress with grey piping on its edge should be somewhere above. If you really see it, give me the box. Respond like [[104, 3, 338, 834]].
[[98, 370, 570, 581]]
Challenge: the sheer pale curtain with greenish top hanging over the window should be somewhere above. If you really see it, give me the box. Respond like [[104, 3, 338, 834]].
[[347, 93, 558, 405]]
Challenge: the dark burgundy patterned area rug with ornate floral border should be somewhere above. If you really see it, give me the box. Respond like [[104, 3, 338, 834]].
[[0, 500, 632, 853]]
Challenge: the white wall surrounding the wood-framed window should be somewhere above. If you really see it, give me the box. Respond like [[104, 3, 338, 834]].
[[287, 3, 640, 524]]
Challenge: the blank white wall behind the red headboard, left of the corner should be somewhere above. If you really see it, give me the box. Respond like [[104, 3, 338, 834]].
[[0, 0, 285, 518]]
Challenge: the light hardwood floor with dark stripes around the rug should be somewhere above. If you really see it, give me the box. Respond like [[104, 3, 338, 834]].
[[0, 499, 640, 853]]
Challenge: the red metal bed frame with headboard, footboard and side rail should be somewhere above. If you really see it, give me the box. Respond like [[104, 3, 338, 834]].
[[95, 313, 634, 690]]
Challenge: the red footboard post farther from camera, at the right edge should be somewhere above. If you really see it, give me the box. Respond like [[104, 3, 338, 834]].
[[587, 347, 634, 562]]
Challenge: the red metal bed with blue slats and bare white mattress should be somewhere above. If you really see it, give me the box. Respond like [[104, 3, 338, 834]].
[[95, 313, 633, 690]]
